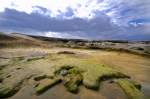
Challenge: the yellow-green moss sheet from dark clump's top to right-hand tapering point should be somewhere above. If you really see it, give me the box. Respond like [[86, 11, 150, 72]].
[[50, 55, 129, 90]]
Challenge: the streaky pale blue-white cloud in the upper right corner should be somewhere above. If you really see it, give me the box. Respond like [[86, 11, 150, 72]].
[[100, 0, 150, 26]]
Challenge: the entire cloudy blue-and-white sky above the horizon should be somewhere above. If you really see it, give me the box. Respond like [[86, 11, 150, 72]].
[[0, 0, 150, 40]]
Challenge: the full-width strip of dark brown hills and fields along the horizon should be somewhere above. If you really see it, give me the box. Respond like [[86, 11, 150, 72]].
[[0, 33, 150, 56]]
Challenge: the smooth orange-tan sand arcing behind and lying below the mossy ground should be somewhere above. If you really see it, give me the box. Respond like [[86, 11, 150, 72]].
[[0, 48, 150, 99]]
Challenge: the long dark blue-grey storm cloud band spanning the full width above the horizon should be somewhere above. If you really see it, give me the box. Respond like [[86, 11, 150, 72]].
[[0, 7, 150, 40]]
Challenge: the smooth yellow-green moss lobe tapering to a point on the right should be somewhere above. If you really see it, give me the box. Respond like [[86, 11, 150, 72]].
[[83, 65, 128, 90]]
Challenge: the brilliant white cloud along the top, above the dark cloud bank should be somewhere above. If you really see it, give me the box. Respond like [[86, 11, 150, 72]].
[[0, 0, 104, 18]]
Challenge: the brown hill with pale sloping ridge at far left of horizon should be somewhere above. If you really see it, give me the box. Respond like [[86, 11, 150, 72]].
[[0, 33, 47, 48]]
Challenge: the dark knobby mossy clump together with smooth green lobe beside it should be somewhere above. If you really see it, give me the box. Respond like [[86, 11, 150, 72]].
[[55, 65, 129, 93]]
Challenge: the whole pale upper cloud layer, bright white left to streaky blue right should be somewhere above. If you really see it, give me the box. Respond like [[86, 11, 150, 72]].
[[0, 0, 150, 26]]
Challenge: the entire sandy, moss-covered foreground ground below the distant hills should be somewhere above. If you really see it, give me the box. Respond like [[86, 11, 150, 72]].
[[0, 48, 150, 99]]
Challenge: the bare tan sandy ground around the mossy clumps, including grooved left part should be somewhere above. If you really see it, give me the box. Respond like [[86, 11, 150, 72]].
[[0, 48, 150, 99]]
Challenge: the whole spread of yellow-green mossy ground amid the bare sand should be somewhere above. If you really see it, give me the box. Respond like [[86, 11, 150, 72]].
[[0, 51, 148, 99]]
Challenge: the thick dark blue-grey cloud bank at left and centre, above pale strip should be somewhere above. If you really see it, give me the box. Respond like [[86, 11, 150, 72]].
[[0, 8, 114, 32]]
